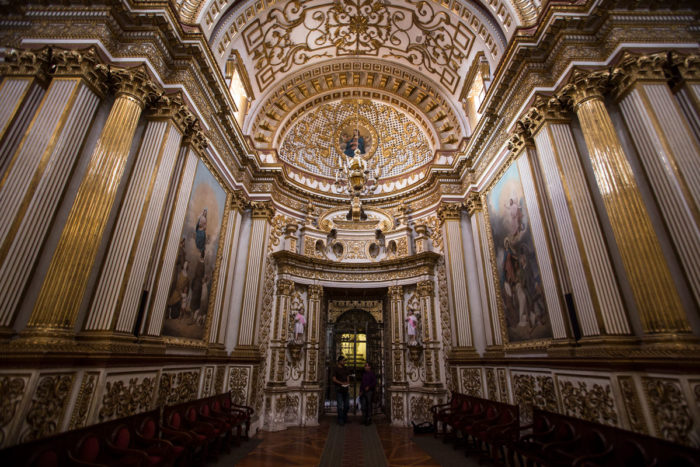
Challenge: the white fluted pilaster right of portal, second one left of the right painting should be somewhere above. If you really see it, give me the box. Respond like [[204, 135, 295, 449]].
[[438, 203, 472, 350]]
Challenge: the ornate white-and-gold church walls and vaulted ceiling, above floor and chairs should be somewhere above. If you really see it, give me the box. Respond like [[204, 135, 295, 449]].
[[0, 0, 700, 465]]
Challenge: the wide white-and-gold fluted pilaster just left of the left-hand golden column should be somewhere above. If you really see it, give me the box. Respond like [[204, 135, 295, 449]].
[[0, 49, 107, 340]]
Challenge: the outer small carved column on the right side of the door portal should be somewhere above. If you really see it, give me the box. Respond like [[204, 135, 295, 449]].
[[416, 280, 442, 387]]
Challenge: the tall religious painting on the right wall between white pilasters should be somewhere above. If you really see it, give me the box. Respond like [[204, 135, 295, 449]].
[[487, 164, 552, 342]]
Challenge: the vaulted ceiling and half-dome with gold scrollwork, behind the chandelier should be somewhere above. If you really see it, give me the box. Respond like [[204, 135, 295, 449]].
[[174, 0, 539, 197]]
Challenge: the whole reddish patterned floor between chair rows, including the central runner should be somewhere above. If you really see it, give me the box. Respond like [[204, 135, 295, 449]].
[[230, 417, 446, 467]]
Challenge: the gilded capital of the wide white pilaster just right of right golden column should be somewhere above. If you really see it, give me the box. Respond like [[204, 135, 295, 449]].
[[611, 52, 669, 100]]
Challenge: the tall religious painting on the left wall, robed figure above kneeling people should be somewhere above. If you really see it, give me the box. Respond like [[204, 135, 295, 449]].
[[163, 161, 226, 340]]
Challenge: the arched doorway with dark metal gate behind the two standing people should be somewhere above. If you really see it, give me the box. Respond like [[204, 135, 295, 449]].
[[324, 309, 384, 414]]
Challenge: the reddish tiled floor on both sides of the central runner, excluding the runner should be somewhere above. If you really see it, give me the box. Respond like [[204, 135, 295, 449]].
[[236, 417, 440, 467]]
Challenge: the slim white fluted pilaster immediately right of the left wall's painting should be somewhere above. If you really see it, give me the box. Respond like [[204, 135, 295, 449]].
[[209, 191, 247, 346]]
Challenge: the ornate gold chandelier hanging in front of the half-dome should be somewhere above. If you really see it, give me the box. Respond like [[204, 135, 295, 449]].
[[335, 98, 379, 221]]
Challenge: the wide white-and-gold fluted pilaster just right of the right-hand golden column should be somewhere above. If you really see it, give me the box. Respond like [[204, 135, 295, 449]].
[[615, 53, 700, 308]]
